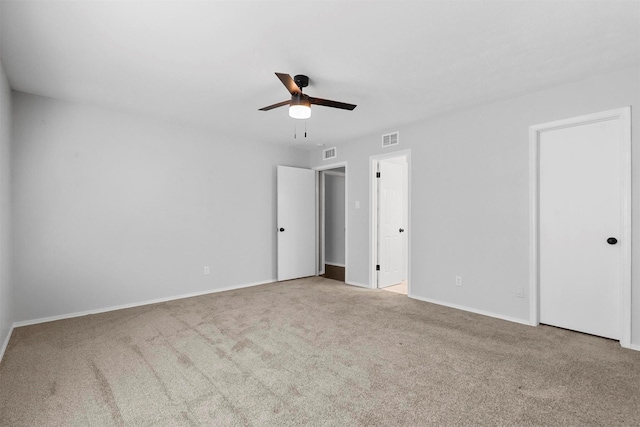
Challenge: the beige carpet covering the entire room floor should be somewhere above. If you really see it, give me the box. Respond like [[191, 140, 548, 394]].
[[0, 278, 640, 426]]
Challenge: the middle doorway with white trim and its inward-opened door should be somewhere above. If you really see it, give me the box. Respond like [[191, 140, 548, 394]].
[[370, 150, 411, 295]]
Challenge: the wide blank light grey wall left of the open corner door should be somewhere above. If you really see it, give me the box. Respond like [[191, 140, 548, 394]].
[[13, 93, 309, 321]]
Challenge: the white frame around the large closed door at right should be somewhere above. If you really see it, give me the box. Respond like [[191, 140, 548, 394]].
[[529, 107, 631, 348]]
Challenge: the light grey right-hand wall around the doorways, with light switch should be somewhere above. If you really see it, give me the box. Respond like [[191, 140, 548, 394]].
[[311, 68, 640, 345]]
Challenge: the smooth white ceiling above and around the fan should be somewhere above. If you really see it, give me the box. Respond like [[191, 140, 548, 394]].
[[0, 0, 640, 148]]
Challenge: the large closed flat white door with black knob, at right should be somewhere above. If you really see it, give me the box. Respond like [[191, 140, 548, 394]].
[[539, 119, 623, 339]]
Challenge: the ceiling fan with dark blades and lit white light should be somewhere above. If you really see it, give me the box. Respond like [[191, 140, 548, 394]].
[[260, 73, 356, 119]]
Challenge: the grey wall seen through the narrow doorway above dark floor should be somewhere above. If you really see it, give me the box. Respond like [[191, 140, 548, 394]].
[[325, 174, 345, 265]]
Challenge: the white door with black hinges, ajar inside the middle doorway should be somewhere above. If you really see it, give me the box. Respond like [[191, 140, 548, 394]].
[[378, 161, 405, 288]]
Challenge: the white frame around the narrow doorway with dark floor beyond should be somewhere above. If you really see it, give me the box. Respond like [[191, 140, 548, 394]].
[[313, 161, 349, 283]]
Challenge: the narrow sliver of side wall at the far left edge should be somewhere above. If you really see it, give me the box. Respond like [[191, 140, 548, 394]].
[[0, 56, 14, 357]]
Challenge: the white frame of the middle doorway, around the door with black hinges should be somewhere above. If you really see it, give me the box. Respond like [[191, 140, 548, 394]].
[[369, 149, 412, 296]]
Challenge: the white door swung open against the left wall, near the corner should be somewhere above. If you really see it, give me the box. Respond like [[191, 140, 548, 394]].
[[277, 166, 316, 281]]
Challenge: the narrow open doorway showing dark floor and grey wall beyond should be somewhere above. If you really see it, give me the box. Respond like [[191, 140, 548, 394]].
[[318, 165, 347, 282]]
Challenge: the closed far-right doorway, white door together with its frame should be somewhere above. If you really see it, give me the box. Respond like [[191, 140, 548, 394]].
[[530, 108, 631, 347]]
